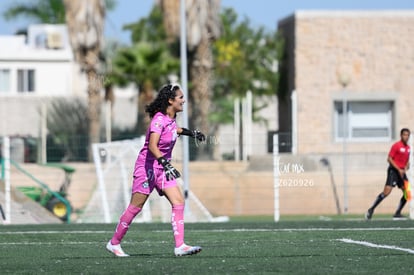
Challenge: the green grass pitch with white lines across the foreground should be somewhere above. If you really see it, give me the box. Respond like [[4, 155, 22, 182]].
[[0, 219, 414, 274]]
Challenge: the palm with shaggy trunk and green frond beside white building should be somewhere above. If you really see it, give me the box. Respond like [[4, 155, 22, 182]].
[[3, 0, 116, 161]]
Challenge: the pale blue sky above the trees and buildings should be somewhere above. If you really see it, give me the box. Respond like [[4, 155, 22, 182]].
[[0, 0, 414, 44]]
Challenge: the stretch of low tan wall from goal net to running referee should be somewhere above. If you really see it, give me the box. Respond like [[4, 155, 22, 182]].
[[190, 164, 409, 218]]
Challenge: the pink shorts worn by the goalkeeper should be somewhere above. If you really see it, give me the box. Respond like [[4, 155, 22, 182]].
[[132, 166, 177, 196]]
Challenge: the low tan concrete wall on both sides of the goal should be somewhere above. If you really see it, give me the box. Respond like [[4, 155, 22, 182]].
[[5, 159, 409, 220]]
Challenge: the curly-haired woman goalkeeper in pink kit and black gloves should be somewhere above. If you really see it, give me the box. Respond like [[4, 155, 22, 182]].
[[106, 85, 205, 257]]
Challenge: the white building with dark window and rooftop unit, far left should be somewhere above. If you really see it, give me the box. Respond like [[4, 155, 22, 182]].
[[0, 24, 138, 160]]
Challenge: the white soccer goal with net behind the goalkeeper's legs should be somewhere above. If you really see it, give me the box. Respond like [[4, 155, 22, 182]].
[[80, 140, 228, 223]]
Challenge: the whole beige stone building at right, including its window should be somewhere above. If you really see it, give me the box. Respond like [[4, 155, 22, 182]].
[[278, 11, 414, 161]]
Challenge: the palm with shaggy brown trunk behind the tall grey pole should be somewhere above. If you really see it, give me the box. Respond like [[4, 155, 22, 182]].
[[160, 0, 221, 158]]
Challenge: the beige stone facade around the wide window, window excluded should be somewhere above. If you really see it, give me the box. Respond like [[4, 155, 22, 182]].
[[279, 11, 414, 154]]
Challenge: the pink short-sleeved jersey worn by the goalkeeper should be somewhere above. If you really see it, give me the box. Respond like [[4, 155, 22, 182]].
[[135, 112, 178, 168]]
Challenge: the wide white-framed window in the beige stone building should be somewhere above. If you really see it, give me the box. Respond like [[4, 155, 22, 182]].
[[334, 101, 394, 141]]
